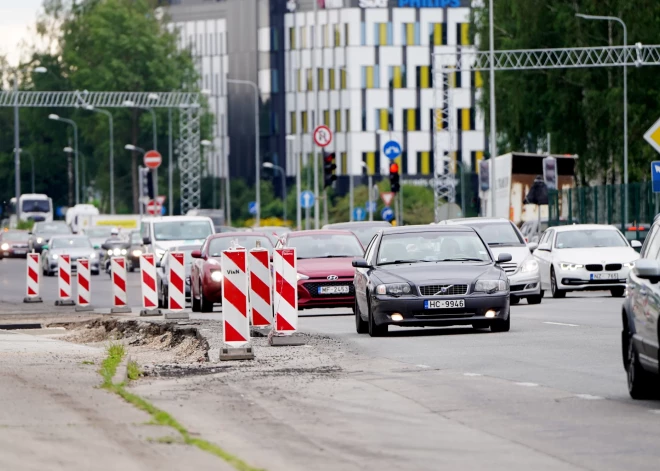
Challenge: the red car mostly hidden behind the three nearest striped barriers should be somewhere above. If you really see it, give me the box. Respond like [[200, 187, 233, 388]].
[[190, 232, 273, 312]]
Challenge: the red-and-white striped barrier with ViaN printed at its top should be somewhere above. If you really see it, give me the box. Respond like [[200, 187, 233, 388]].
[[220, 247, 250, 347]]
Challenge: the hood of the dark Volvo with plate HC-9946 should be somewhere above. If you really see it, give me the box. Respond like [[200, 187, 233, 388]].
[[374, 262, 502, 285]]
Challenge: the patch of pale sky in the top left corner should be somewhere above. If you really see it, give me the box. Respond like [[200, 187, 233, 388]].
[[0, 0, 42, 65]]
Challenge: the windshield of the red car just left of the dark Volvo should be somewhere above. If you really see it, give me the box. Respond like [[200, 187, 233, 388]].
[[287, 234, 364, 258]]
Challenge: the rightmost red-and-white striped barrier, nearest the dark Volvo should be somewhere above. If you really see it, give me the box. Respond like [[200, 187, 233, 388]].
[[273, 248, 298, 334]]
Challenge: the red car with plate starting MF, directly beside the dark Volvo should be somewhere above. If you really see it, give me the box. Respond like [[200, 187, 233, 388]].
[[278, 230, 364, 309]]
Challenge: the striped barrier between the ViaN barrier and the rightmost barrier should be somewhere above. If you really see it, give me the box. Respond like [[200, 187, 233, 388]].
[[248, 248, 273, 327]]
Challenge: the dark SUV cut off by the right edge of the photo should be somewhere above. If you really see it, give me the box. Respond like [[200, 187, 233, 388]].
[[621, 222, 660, 399]]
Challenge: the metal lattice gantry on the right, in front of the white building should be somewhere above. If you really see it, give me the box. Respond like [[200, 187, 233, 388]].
[[432, 43, 660, 220]]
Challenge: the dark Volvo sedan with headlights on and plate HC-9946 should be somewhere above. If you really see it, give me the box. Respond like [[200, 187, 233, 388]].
[[353, 225, 511, 337]]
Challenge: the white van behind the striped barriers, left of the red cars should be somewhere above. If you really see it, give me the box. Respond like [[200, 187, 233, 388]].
[[140, 216, 215, 261]]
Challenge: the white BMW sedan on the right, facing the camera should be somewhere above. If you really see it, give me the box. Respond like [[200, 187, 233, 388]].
[[534, 224, 641, 298]]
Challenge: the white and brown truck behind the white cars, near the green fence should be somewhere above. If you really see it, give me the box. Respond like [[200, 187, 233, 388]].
[[479, 152, 578, 226]]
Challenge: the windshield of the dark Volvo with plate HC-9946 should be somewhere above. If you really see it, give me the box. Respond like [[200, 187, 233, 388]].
[[377, 231, 492, 265]]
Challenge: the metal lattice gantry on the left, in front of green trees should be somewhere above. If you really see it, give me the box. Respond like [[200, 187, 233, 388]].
[[0, 91, 201, 214]]
